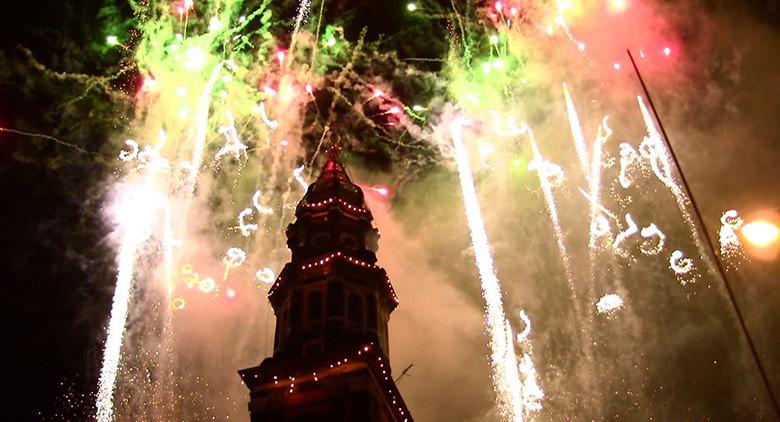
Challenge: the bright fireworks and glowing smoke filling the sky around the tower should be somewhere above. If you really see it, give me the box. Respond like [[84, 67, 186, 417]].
[[0, 0, 780, 421]]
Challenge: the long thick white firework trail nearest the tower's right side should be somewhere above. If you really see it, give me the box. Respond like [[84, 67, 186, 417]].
[[449, 117, 523, 421]]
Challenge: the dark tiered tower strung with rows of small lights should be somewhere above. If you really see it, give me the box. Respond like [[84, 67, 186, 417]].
[[238, 149, 413, 422]]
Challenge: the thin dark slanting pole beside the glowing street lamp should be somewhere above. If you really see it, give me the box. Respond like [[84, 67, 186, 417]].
[[626, 50, 780, 420]]
